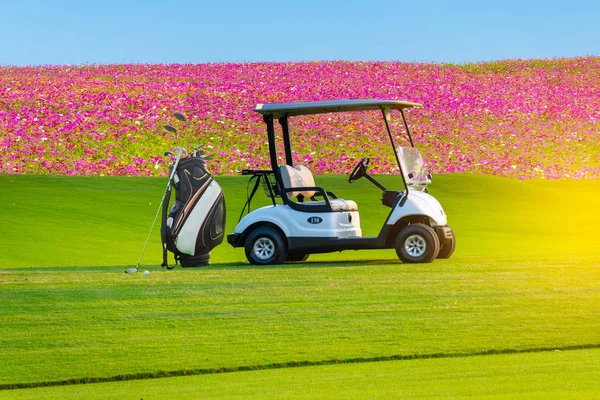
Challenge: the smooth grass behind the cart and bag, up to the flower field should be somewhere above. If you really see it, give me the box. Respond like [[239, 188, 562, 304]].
[[0, 175, 600, 268]]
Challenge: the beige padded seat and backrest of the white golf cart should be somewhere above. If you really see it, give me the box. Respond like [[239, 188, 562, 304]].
[[279, 165, 358, 211]]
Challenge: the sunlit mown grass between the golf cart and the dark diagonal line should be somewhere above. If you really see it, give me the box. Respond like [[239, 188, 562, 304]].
[[0, 259, 600, 384]]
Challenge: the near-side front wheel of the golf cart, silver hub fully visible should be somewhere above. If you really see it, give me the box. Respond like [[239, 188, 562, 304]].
[[396, 224, 440, 264]]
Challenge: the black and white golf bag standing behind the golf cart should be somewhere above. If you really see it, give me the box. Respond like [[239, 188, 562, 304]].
[[160, 153, 225, 268]]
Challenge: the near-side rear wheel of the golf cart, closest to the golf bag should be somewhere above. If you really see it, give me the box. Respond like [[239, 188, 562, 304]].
[[245, 227, 287, 265]]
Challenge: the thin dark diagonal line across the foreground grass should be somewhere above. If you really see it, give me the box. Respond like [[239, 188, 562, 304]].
[[0, 343, 600, 391]]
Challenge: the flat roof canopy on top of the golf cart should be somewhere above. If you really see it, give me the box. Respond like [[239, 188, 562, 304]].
[[254, 99, 423, 119]]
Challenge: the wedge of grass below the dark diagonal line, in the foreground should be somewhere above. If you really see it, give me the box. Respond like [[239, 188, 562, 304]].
[[2, 350, 600, 400]]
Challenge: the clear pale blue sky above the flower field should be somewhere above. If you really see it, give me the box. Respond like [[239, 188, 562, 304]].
[[0, 0, 600, 65]]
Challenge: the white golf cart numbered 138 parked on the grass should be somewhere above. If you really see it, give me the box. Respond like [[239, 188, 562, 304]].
[[227, 99, 456, 265]]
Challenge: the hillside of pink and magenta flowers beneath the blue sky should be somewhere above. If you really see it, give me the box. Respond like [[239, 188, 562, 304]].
[[0, 57, 600, 179]]
